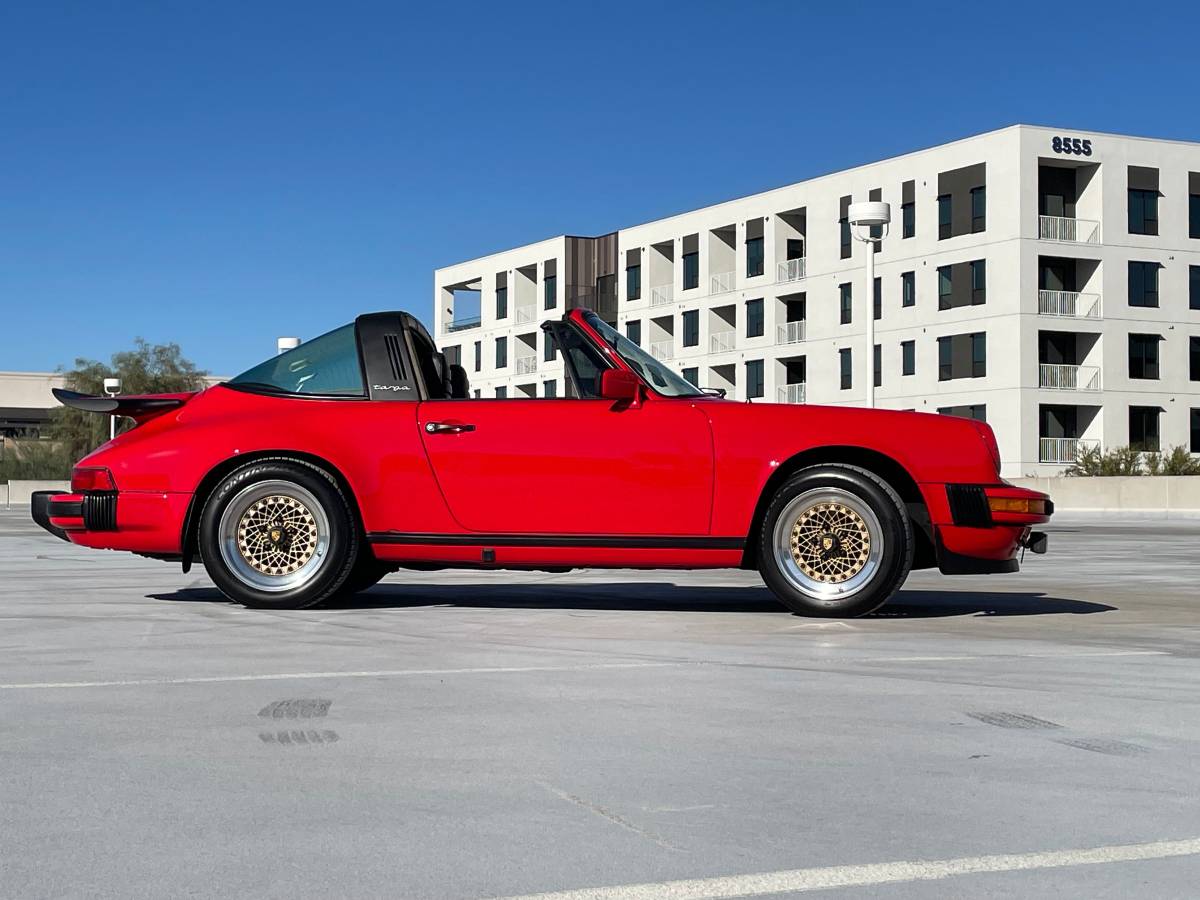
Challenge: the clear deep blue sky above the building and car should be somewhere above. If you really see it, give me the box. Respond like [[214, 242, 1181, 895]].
[[0, 0, 1200, 374]]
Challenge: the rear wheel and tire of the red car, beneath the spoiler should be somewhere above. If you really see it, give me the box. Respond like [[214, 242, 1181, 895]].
[[197, 458, 360, 610]]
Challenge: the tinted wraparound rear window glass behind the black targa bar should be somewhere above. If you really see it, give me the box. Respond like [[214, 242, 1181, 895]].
[[229, 323, 365, 397]]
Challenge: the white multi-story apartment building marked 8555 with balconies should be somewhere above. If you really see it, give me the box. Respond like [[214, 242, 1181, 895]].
[[434, 125, 1200, 475]]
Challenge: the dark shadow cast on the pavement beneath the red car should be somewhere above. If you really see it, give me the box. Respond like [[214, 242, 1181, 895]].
[[148, 581, 1117, 619]]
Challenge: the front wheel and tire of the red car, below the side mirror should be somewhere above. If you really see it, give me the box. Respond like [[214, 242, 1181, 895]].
[[758, 463, 914, 618]]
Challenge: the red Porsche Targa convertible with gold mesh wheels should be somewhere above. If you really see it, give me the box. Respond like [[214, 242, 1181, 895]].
[[32, 310, 1052, 616]]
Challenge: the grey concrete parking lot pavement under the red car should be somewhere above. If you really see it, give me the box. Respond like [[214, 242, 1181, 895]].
[[0, 510, 1200, 900]]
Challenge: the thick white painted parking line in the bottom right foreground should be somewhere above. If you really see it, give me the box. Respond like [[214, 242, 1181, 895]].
[[484, 838, 1200, 900]]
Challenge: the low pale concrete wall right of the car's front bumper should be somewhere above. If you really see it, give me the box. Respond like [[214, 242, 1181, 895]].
[[1008, 475, 1200, 518]]
